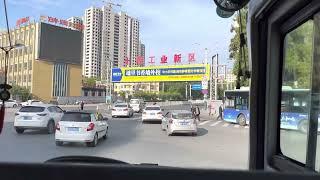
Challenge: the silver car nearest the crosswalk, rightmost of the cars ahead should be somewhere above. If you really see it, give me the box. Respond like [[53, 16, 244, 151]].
[[161, 110, 198, 136]]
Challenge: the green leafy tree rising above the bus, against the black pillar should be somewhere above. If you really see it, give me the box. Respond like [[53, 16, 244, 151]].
[[229, 7, 249, 86]]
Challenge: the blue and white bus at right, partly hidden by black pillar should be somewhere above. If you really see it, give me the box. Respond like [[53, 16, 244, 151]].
[[223, 86, 320, 132]]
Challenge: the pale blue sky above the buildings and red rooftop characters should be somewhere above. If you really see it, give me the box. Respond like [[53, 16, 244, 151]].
[[0, 0, 232, 66]]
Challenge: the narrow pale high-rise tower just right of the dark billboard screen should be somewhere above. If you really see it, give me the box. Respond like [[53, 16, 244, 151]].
[[82, 7, 102, 77]]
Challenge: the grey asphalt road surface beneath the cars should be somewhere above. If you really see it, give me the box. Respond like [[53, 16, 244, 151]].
[[0, 107, 249, 169]]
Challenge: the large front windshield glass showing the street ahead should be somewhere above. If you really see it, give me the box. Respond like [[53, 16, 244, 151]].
[[0, 0, 255, 169]]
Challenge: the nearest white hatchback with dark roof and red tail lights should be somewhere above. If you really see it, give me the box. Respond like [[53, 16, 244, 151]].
[[55, 111, 109, 147]]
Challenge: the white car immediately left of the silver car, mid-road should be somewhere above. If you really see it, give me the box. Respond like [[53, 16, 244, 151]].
[[142, 105, 162, 122]]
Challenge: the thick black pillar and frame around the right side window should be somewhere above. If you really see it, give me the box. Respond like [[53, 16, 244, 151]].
[[247, 0, 320, 173]]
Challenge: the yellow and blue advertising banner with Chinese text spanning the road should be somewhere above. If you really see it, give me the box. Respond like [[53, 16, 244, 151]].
[[112, 64, 210, 82]]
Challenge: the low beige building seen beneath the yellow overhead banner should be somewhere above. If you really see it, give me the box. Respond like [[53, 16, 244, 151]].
[[114, 82, 160, 95]]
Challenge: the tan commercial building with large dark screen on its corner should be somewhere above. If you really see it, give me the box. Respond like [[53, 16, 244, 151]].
[[0, 22, 82, 101]]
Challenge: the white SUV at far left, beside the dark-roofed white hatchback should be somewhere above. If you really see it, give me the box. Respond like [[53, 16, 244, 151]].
[[14, 104, 63, 134]]
